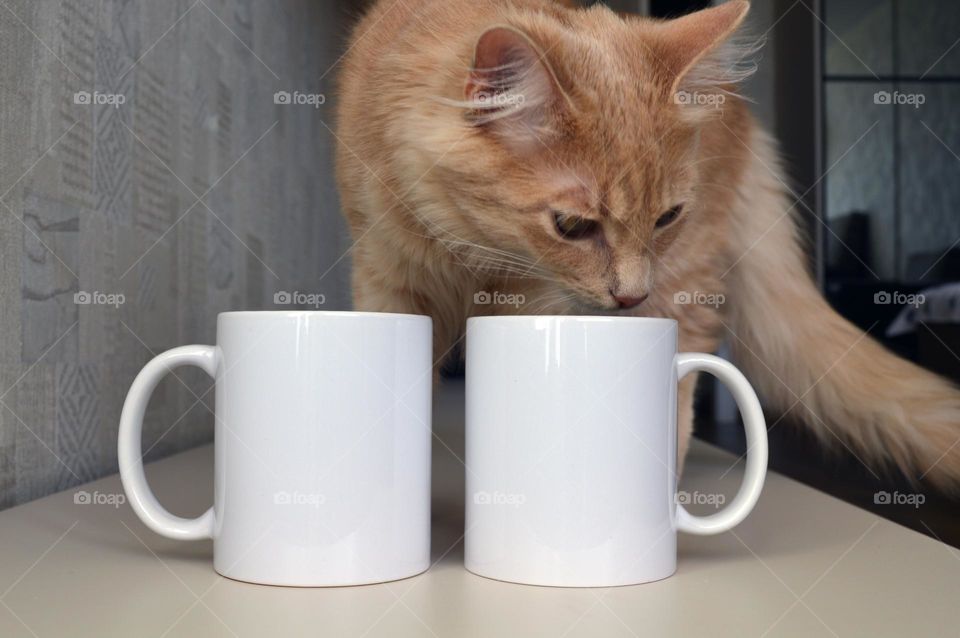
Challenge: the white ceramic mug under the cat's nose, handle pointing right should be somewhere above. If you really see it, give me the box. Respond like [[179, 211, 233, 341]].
[[465, 316, 767, 587]]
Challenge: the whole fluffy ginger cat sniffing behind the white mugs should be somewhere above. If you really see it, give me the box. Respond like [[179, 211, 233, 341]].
[[336, 0, 960, 490]]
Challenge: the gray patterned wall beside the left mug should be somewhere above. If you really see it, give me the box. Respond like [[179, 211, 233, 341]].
[[0, 0, 349, 507]]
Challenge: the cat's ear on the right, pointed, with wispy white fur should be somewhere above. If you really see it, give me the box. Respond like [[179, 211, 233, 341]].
[[655, 0, 756, 103]]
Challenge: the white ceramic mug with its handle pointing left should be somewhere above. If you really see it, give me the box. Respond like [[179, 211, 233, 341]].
[[119, 311, 433, 586]]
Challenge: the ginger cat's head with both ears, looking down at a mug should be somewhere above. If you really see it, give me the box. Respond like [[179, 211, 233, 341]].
[[433, 1, 749, 310]]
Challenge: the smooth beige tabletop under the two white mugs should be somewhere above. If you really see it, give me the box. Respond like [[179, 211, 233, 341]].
[[0, 386, 960, 638]]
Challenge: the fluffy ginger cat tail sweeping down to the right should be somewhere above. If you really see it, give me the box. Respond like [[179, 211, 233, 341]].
[[725, 128, 960, 493]]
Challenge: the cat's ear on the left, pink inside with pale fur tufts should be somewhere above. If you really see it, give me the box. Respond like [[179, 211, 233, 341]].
[[464, 26, 566, 153]]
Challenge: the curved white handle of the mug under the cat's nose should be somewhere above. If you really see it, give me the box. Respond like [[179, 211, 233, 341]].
[[676, 352, 768, 536]]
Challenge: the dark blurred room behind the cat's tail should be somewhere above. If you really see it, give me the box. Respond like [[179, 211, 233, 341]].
[[608, 0, 960, 546]]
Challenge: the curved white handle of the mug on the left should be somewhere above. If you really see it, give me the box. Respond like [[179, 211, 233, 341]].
[[117, 346, 218, 540]]
